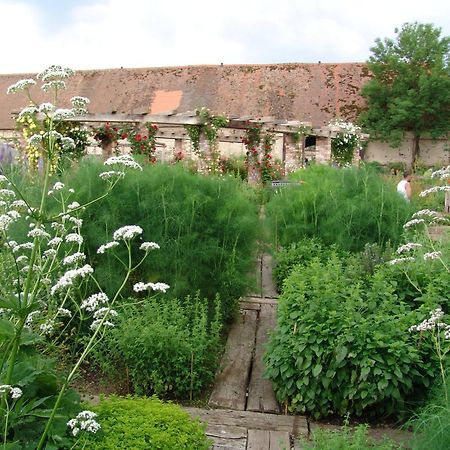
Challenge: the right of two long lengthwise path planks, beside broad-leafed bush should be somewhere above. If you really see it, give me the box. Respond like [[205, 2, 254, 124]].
[[246, 304, 280, 413]]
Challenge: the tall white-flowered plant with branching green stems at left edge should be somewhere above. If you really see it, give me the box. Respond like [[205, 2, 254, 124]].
[[0, 66, 166, 449]]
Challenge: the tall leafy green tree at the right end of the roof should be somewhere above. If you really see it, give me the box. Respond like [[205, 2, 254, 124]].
[[359, 22, 450, 166]]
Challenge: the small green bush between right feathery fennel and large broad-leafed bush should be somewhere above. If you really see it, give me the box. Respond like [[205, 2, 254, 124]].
[[273, 238, 350, 292]]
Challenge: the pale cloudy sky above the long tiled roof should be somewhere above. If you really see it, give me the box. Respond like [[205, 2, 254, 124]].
[[0, 0, 450, 73]]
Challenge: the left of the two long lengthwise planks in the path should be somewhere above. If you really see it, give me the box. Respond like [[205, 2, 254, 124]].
[[209, 310, 258, 411]]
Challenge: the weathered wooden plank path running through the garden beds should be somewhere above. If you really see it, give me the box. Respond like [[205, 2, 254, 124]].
[[184, 253, 410, 450]]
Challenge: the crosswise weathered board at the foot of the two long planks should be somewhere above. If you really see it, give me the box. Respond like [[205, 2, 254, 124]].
[[183, 407, 308, 436]]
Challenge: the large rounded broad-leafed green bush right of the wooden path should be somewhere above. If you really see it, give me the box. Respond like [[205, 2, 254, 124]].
[[265, 255, 433, 417]]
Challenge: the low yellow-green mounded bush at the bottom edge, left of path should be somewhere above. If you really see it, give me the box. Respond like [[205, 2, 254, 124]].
[[77, 397, 211, 450]]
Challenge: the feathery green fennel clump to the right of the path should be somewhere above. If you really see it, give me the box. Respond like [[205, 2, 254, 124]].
[[266, 165, 411, 251]]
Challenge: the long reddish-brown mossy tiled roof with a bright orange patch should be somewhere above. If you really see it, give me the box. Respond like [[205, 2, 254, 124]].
[[0, 63, 370, 129]]
